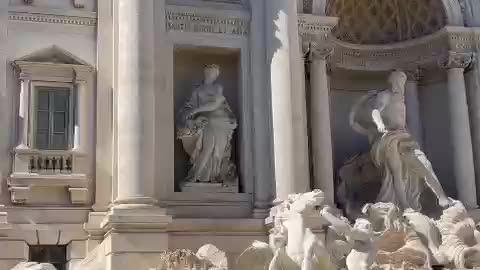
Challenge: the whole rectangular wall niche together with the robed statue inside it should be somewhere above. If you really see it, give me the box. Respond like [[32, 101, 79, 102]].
[[174, 48, 240, 193]]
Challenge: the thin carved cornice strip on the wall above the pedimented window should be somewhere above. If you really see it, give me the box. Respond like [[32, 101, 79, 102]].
[[8, 11, 97, 26]]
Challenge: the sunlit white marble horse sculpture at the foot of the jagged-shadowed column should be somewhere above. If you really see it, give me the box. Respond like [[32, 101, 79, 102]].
[[237, 190, 334, 270]]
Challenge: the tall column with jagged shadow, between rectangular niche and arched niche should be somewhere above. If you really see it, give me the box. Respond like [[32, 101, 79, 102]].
[[265, 0, 310, 202]]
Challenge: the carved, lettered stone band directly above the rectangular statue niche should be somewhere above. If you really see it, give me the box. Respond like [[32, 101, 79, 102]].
[[165, 6, 250, 36]]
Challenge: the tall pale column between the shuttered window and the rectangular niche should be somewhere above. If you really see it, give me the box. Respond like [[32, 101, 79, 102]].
[[115, 0, 155, 204]]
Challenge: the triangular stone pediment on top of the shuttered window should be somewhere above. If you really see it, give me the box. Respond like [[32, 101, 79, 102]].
[[16, 45, 90, 66]]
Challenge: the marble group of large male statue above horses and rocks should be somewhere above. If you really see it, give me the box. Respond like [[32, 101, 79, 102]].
[[238, 71, 480, 270]]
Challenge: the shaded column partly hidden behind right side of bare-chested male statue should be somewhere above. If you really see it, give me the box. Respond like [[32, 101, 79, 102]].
[[405, 70, 423, 147]]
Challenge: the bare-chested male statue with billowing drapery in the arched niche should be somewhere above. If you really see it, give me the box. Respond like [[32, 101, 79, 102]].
[[350, 71, 450, 211]]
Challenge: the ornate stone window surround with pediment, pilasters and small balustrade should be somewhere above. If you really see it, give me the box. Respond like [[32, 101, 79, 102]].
[[7, 46, 95, 205]]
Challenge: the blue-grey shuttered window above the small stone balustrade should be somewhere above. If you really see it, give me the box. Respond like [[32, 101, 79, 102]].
[[35, 87, 70, 150]]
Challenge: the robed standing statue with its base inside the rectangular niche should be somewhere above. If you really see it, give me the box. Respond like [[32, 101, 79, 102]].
[[177, 65, 238, 192]]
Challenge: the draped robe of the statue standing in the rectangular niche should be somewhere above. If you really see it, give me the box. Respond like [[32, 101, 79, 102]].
[[177, 86, 237, 182]]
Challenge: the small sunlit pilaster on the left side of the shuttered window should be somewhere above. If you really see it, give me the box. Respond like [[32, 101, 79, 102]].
[[17, 74, 30, 149]]
